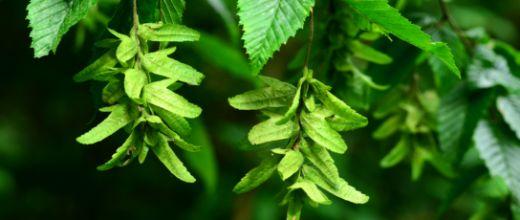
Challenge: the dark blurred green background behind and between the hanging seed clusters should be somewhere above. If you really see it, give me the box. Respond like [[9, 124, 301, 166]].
[[0, 0, 520, 220]]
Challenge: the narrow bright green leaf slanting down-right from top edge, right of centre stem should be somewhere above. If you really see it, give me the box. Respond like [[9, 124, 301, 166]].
[[344, 0, 460, 78]]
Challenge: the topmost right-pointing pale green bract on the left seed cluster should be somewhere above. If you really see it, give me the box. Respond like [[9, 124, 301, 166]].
[[137, 23, 200, 42]]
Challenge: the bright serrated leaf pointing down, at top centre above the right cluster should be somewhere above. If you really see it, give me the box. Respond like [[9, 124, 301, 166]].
[[238, 0, 314, 74]]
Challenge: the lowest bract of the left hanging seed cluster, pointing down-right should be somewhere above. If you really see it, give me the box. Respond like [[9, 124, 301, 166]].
[[152, 134, 195, 183]]
